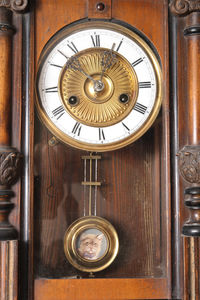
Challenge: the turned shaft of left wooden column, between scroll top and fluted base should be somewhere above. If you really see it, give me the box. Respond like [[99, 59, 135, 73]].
[[0, 7, 20, 240]]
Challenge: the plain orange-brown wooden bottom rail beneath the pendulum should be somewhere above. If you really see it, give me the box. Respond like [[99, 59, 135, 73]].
[[35, 278, 170, 300]]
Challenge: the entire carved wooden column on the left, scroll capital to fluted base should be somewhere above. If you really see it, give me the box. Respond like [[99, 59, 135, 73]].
[[0, 0, 27, 300]]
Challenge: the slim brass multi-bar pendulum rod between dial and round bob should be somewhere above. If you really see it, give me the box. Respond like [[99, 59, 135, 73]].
[[82, 153, 101, 216]]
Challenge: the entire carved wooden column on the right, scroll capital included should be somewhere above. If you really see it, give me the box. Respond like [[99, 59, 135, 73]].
[[170, 0, 200, 300]]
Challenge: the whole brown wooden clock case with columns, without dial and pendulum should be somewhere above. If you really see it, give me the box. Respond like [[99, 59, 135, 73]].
[[0, 0, 200, 300]]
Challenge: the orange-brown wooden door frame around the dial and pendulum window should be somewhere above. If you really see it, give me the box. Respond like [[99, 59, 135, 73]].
[[34, 1, 171, 300]]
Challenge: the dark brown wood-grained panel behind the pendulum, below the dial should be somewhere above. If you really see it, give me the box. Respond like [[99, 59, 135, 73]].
[[34, 115, 167, 278]]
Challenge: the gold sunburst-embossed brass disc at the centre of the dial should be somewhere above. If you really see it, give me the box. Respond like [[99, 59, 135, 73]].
[[59, 48, 138, 127]]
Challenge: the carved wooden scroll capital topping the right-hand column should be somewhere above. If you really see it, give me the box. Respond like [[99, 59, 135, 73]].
[[169, 0, 200, 16]]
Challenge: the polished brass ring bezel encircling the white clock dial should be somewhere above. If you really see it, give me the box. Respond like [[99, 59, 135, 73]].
[[36, 21, 163, 152]]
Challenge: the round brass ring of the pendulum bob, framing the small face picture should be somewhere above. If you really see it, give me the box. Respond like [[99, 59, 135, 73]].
[[64, 216, 119, 272]]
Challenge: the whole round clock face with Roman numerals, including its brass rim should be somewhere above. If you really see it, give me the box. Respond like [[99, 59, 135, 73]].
[[36, 22, 162, 151]]
